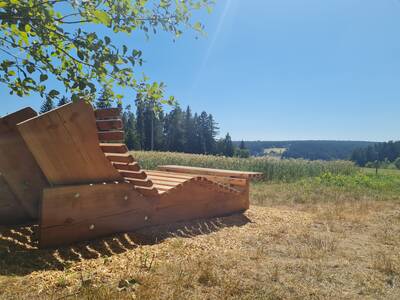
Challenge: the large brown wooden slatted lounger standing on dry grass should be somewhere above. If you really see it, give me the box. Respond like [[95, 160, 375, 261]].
[[0, 101, 261, 247]]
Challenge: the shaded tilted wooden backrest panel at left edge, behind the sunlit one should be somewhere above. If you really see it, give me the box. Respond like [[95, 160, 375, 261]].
[[0, 108, 48, 219]]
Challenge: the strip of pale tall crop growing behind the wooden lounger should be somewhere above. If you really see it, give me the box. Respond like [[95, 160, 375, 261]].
[[132, 151, 357, 182]]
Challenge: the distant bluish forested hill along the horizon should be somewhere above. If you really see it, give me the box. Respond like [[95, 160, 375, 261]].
[[234, 141, 376, 160]]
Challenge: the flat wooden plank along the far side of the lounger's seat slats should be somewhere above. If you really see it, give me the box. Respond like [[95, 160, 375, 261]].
[[158, 165, 262, 179]]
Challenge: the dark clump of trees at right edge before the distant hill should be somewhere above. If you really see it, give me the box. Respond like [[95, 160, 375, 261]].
[[351, 141, 400, 168]]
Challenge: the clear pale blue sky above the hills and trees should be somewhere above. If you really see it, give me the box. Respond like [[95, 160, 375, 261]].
[[0, 0, 400, 141]]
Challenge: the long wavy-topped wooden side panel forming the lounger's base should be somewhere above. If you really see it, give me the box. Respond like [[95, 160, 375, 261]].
[[40, 181, 249, 247]]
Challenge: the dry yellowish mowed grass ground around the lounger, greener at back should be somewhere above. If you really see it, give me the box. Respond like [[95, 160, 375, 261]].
[[0, 153, 400, 299]]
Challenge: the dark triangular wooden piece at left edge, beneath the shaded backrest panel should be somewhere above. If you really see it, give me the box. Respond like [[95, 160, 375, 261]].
[[0, 176, 31, 225]]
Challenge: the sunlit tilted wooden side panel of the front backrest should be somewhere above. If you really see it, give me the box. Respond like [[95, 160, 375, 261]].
[[18, 101, 123, 185]]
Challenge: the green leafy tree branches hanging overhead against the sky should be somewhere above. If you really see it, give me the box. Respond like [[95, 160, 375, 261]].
[[0, 0, 214, 102]]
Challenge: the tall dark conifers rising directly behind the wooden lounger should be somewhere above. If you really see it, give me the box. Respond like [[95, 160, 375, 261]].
[[40, 94, 249, 157]]
